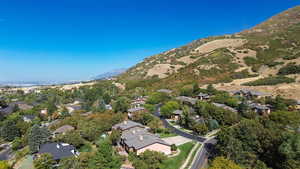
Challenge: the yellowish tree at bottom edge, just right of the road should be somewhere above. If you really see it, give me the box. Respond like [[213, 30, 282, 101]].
[[209, 157, 242, 169]]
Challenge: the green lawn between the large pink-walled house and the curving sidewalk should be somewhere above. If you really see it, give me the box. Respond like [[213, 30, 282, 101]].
[[160, 142, 195, 169]]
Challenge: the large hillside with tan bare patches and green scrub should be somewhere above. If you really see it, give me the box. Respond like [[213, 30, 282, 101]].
[[119, 6, 300, 99]]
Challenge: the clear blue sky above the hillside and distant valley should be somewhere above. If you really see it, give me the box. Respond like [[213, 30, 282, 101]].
[[0, 0, 299, 81]]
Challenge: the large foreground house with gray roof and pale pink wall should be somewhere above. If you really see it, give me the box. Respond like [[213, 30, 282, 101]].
[[120, 127, 172, 155]]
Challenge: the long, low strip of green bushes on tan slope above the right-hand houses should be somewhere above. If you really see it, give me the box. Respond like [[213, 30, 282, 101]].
[[242, 76, 295, 86]]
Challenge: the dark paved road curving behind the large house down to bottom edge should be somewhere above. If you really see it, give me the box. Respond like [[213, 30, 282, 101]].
[[154, 106, 217, 169]]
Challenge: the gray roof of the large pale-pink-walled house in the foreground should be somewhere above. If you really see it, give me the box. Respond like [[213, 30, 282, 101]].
[[121, 128, 169, 150]]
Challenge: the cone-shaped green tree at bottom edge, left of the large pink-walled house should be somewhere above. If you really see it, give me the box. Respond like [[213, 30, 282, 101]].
[[88, 140, 121, 169]]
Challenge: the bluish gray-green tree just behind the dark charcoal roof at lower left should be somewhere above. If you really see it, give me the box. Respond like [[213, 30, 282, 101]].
[[28, 125, 50, 153]]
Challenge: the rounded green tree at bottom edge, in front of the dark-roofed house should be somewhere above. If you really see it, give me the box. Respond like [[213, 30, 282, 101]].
[[33, 153, 55, 169]]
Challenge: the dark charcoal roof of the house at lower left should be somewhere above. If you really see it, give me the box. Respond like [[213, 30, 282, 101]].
[[38, 143, 76, 160]]
